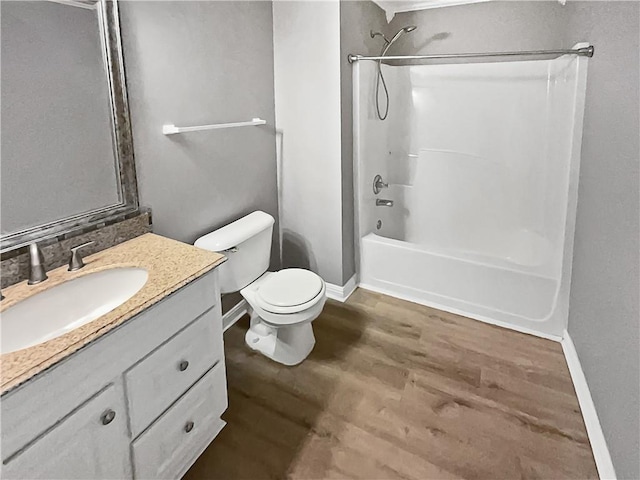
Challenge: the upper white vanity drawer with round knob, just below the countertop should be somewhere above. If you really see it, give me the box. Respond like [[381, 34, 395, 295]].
[[125, 308, 223, 438]]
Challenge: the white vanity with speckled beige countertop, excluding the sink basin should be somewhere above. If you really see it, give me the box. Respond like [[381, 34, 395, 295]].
[[0, 234, 227, 479]]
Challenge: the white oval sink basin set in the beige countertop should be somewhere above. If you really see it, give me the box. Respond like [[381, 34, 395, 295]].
[[0, 268, 149, 353]]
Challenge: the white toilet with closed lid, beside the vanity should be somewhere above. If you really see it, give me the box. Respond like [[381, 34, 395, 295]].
[[195, 211, 326, 365]]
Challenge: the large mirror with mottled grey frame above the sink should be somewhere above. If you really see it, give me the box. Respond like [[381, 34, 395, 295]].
[[0, 0, 138, 252]]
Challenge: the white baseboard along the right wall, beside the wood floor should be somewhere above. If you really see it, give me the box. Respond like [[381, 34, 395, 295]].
[[562, 330, 616, 480]]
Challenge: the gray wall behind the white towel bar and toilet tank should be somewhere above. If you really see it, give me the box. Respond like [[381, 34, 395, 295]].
[[120, 1, 279, 266]]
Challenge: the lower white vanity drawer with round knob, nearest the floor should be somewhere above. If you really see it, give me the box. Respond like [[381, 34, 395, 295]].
[[133, 362, 227, 479]]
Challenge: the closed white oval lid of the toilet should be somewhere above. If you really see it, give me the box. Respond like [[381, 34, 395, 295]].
[[257, 268, 322, 307]]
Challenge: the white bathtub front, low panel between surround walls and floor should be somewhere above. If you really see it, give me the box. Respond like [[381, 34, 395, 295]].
[[360, 233, 563, 339]]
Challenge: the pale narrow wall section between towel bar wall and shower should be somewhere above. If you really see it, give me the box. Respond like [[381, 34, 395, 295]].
[[273, 0, 342, 285]]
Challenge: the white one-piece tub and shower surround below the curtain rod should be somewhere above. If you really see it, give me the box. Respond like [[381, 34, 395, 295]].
[[353, 44, 588, 339]]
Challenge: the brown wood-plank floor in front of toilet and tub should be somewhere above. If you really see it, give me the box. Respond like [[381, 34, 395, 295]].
[[185, 289, 597, 480]]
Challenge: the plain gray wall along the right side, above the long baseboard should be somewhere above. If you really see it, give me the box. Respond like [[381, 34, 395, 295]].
[[567, 1, 640, 479]]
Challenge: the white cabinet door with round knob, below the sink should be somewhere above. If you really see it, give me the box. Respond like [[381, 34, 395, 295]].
[[1, 385, 132, 480]]
